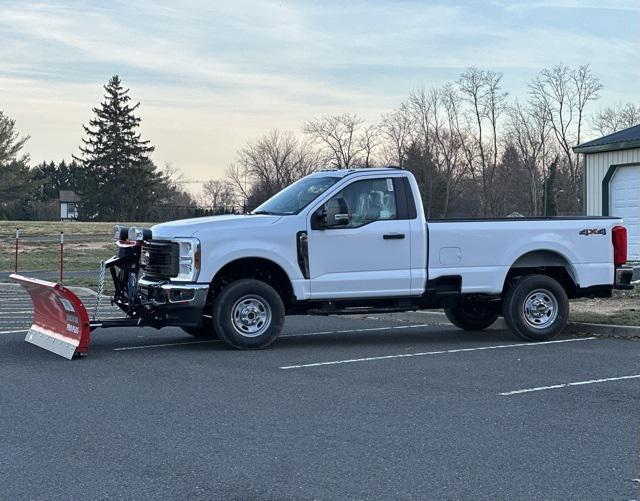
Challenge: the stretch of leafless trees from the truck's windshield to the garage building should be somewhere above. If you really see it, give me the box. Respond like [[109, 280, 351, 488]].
[[214, 64, 640, 218]]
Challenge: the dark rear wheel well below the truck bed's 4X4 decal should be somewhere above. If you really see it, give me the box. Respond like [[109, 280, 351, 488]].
[[503, 250, 578, 298]]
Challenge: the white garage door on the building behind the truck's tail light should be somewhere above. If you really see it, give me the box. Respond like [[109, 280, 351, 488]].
[[609, 165, 640, 261]]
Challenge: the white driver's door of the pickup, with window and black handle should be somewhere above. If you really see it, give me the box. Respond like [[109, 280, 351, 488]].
[[308, 177, 411, 299]]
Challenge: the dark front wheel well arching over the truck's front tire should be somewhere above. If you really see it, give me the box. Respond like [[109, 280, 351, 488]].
[[211, 257, 294, 306]]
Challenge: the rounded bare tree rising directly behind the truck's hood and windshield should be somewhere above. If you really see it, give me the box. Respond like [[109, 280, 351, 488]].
[[227, 130, 320, 207]]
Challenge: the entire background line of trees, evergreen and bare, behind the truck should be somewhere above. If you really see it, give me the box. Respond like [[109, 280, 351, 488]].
[[0, 64, 640, 221]]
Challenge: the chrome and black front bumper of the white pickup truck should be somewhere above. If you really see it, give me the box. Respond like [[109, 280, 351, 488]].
[[138, 278, 209, 327]]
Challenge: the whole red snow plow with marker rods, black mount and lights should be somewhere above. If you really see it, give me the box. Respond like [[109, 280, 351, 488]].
[[10, 226, 186, 359]]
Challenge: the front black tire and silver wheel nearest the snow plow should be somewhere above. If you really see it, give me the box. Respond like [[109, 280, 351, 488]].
[[213, 279, 284, 350]]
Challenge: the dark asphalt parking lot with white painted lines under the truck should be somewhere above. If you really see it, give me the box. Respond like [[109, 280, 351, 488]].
[[0, 286, 640, 500]]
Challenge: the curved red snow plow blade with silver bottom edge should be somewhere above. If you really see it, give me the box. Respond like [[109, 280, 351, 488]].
[[10, 274, 91, 360]]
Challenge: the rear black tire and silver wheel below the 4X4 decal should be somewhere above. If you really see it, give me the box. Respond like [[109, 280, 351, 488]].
[[503, 275, 569, 341]]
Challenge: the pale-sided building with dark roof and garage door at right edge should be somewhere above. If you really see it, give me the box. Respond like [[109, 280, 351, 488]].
[[573, 125, 640, 261]]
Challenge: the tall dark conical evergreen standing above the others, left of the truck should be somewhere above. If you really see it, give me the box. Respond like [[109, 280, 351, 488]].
[[74, 75, 156, 221]]
